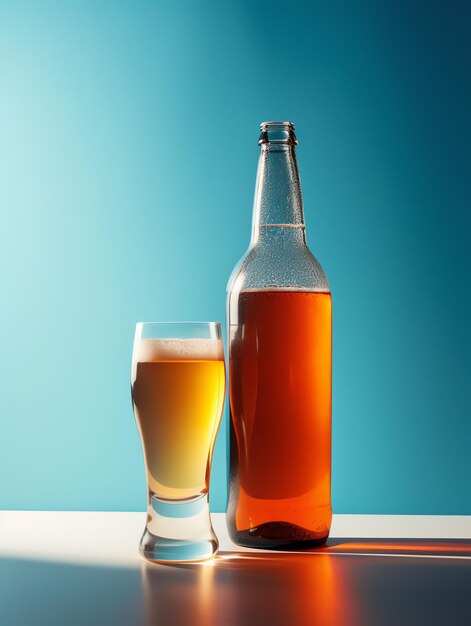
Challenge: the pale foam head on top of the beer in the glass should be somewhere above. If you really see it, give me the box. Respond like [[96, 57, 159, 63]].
[[133, 339, 224, 363]]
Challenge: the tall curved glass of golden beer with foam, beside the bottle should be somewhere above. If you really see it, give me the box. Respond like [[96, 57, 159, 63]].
[[131, 322, 225, 562]]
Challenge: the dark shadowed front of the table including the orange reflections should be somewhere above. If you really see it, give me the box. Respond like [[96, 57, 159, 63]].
[[0, 539, 471, 626]]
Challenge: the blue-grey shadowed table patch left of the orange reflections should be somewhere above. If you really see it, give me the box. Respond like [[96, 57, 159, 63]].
[[0, 558, 144, 626]]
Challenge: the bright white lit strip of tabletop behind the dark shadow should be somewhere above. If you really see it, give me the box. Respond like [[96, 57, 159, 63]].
[[0, 511, 471, 567]]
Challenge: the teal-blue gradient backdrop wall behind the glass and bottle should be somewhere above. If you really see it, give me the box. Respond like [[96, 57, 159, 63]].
[[0, 0, 471, 514]]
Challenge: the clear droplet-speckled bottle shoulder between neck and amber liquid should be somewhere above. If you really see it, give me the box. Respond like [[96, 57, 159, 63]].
[[227, 242, 330, 294]]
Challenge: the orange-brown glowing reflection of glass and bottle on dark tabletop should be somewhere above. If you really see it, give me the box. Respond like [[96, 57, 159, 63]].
[[142, 552, 361, 626]]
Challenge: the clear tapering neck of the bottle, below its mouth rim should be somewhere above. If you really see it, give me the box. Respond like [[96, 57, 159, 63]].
[[250, 143, 306, 246]]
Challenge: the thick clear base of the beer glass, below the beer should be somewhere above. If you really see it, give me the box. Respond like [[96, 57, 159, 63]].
[[139, 494, 219, 563]]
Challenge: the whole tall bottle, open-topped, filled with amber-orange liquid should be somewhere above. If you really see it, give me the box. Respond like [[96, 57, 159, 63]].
[[227, 122, 332, 548]]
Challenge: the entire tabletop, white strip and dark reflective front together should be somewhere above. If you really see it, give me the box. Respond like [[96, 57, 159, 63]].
[[0, 511, 471, 626]]
